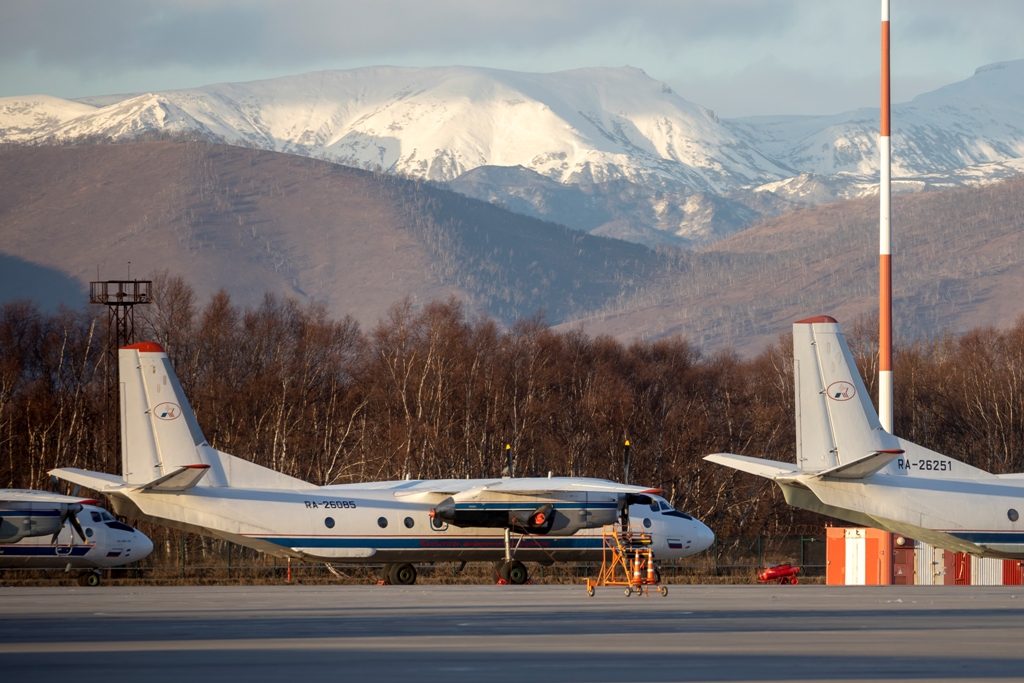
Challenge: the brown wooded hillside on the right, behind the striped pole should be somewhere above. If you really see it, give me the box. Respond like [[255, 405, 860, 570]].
[[565, 178, 1024, 352]]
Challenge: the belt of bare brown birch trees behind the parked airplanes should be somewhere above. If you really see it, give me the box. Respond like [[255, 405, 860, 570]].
[[0, 274, 1024, 536]]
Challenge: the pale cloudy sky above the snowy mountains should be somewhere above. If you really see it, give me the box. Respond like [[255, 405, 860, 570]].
[[0, 0, 1024, 117]]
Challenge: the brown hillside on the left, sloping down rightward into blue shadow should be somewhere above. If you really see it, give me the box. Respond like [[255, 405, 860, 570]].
[[0, 141, 656, 325]]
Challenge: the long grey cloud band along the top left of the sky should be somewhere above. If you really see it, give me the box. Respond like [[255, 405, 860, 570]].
[[0, 0, 785, 70]]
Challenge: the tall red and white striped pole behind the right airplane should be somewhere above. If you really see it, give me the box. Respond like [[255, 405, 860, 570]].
[[879, 0, 893, 434]]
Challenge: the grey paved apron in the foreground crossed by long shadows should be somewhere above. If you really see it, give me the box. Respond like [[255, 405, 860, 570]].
[[0, 585, 1024, 683]]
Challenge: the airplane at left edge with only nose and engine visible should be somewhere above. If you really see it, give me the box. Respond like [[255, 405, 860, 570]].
[[0, 488, 153, 586]]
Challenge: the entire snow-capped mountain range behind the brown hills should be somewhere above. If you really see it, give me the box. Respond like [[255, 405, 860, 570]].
[[0, 59, 1024, 247]]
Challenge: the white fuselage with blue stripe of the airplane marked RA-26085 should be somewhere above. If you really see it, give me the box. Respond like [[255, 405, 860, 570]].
[[111, 480, 714, 563]]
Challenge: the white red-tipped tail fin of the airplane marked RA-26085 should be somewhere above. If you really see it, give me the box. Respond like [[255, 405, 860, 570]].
[[118, 342, 310, 490]]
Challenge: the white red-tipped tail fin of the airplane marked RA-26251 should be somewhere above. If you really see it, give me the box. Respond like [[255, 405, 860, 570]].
[[793, 315, 902, 476]]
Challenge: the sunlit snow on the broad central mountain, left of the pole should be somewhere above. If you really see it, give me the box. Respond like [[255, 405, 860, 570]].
[[4, 67, 792, 191]]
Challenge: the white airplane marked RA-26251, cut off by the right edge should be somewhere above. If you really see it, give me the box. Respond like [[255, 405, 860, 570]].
[[705, 315, 1024, 559]]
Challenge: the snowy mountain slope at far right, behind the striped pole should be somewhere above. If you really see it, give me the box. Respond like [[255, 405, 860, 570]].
[[724, 59, 1024, 177]]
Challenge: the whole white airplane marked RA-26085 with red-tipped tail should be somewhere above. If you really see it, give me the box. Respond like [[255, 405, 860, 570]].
[[51, 342, 715, 585]]
